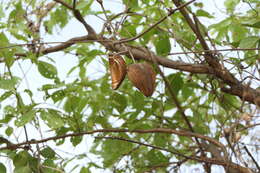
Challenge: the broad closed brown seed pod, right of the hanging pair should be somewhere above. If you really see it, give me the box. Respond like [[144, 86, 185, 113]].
[[127, 63, 156, 97]]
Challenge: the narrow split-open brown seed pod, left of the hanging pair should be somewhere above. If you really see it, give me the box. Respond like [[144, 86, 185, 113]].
[[109, 55, 126, 90]]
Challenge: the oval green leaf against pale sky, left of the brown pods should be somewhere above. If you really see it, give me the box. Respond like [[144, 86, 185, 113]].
[[38, 61, 57, 79]]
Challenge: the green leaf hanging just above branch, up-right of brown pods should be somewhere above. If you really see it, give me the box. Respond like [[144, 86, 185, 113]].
[[155, 34, 171, 56]]
